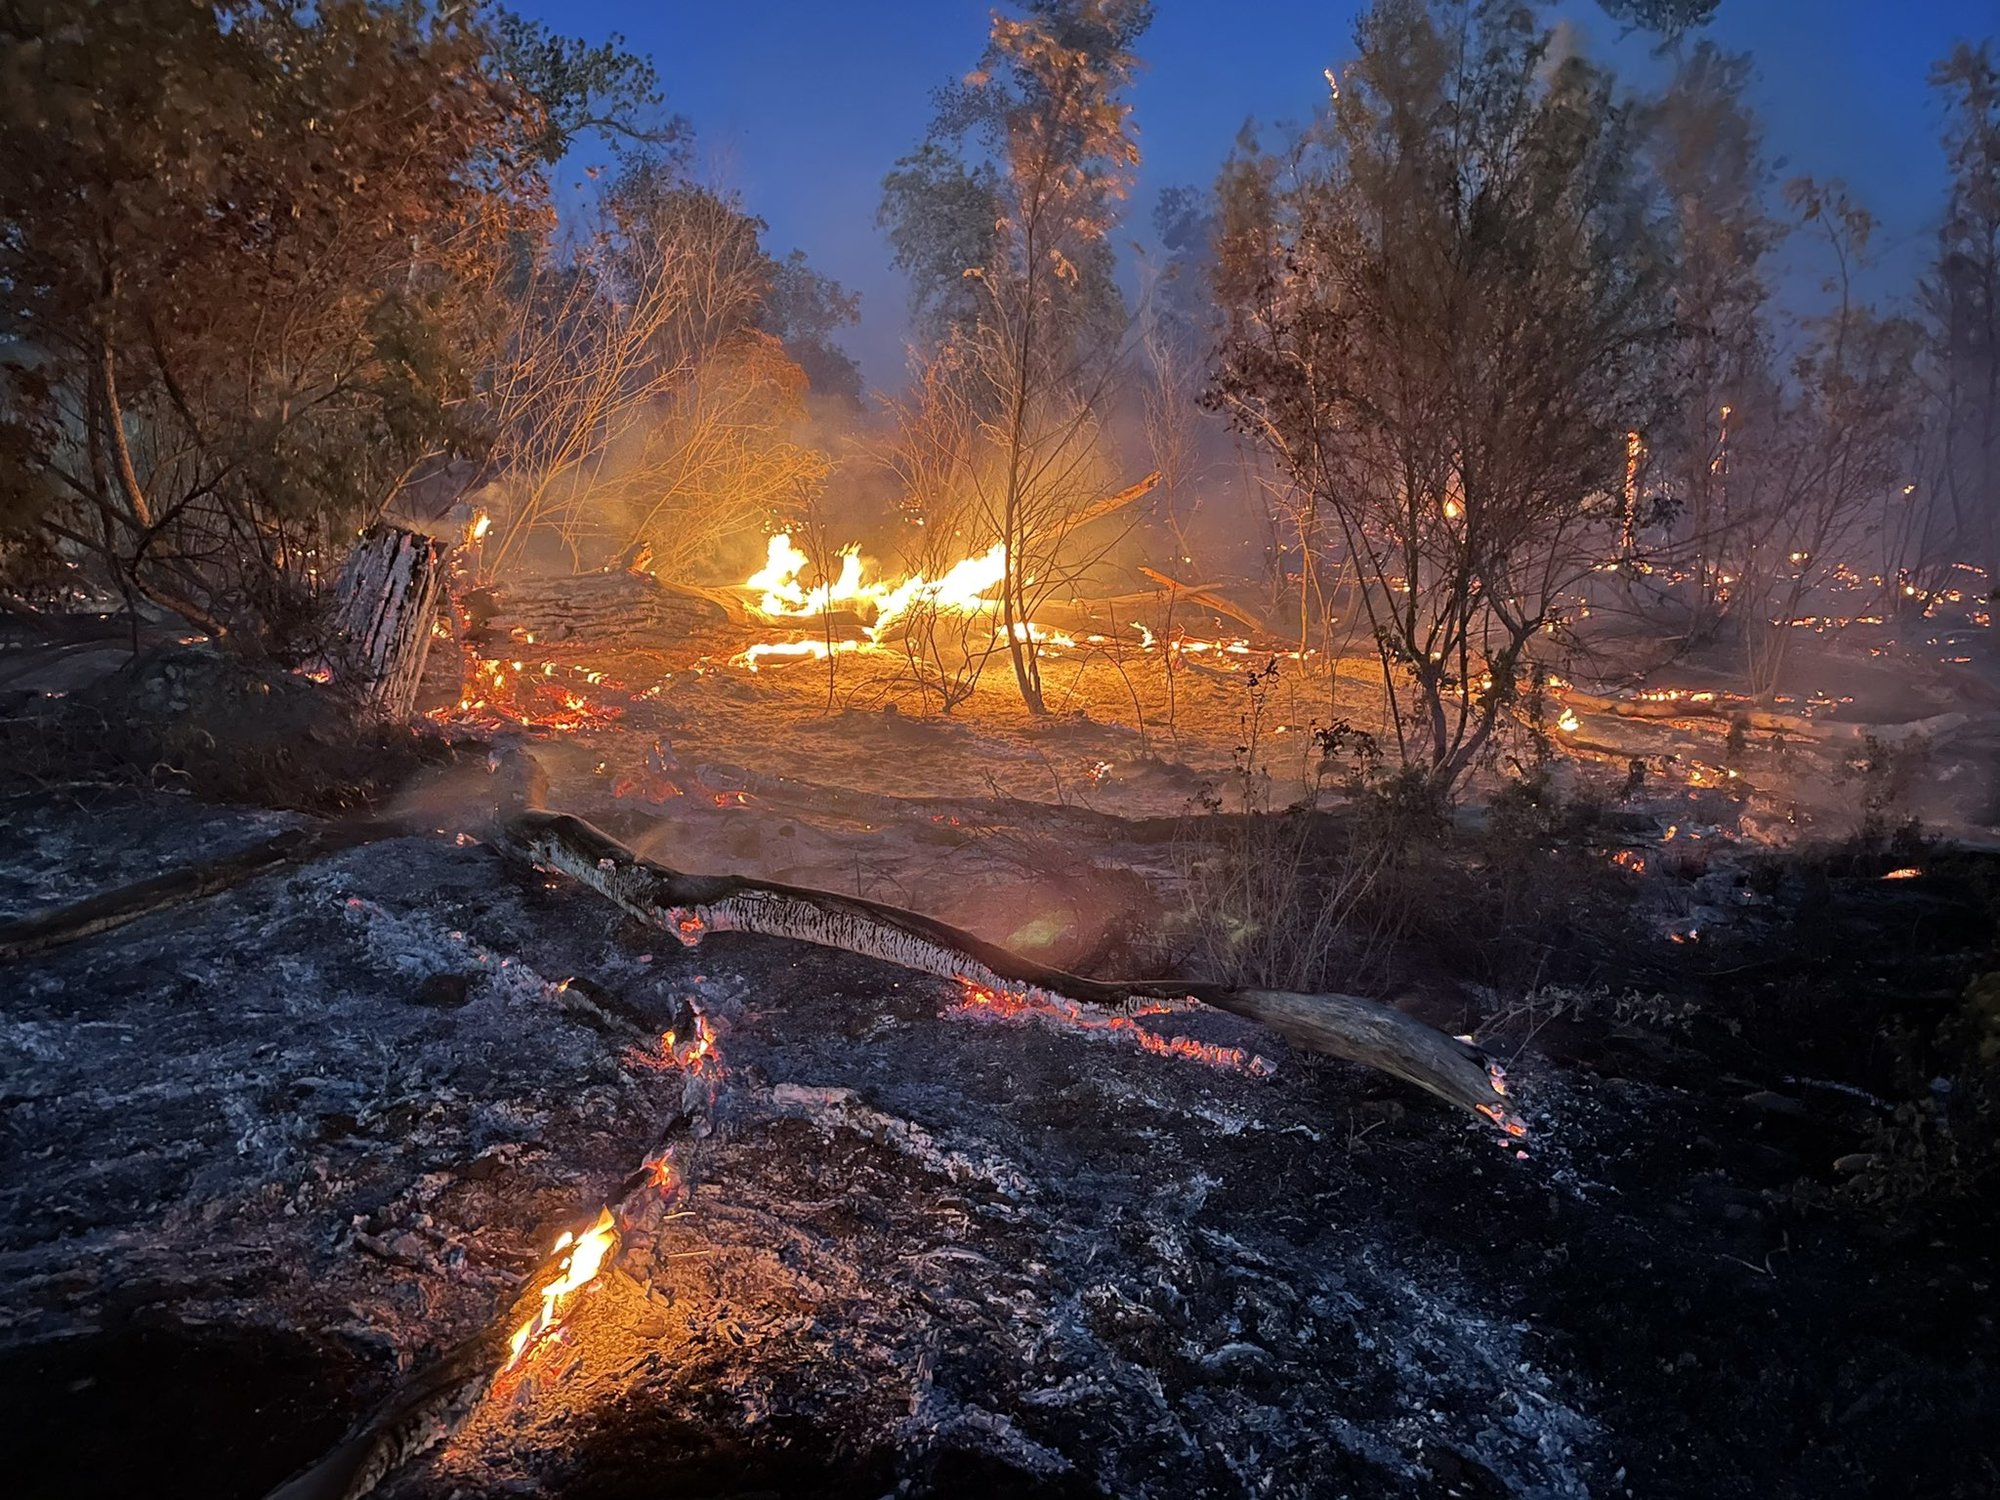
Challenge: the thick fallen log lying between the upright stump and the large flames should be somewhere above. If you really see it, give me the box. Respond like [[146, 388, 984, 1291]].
[[464, 568, 746, 656]]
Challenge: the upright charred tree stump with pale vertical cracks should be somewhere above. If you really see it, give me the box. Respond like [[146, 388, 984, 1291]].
[[332, 526, 446, 718]]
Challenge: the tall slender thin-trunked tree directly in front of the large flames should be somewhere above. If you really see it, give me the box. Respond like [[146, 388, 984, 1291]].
[[882, 0, 1152, 714]]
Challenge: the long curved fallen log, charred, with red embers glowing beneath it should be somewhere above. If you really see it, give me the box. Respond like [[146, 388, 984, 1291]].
[[502, 810, 1526, 1136]]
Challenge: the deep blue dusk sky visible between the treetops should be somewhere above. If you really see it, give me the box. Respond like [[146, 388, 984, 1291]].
[[520, 0, 2000, 384]]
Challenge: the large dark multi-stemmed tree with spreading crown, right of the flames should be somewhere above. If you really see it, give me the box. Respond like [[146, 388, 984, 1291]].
[[1216, 0, 1668, 796]]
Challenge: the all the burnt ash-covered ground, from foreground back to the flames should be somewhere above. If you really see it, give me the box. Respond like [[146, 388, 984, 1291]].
[[0, 612, 2000, 1500]]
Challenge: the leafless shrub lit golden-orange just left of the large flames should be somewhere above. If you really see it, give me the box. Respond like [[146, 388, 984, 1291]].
[[486, 174, 826, 574]]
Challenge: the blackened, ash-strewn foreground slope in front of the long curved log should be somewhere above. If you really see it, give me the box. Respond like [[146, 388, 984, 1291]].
[[0, 798, 1992, 1500]]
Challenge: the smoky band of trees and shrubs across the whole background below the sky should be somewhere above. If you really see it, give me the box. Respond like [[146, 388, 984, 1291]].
[[0, 0, 2000, 794]]
